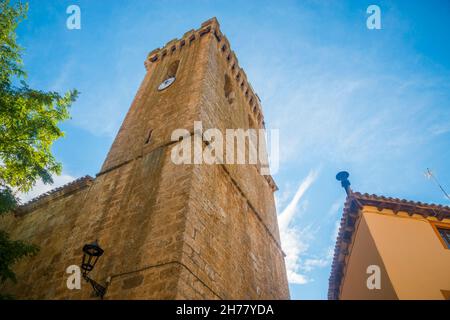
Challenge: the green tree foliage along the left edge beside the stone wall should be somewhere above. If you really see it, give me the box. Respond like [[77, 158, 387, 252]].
[[0, 0, 78, 292]]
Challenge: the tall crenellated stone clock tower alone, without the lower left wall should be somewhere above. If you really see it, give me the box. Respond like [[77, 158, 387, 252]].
[[92, 18, 289, 299]]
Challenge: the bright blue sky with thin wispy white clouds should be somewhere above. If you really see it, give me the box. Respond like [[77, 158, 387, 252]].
[[18, 0, 450, 299]]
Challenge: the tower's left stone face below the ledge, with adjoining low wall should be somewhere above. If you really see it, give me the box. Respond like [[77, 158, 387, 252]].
[[1, 148, 192, 299]]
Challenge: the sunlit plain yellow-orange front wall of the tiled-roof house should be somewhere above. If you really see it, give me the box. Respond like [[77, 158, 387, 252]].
[[363, 207, 450, 299]]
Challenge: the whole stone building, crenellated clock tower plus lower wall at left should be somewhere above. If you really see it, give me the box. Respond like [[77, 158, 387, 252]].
[[0, 18, 289, 299]]
